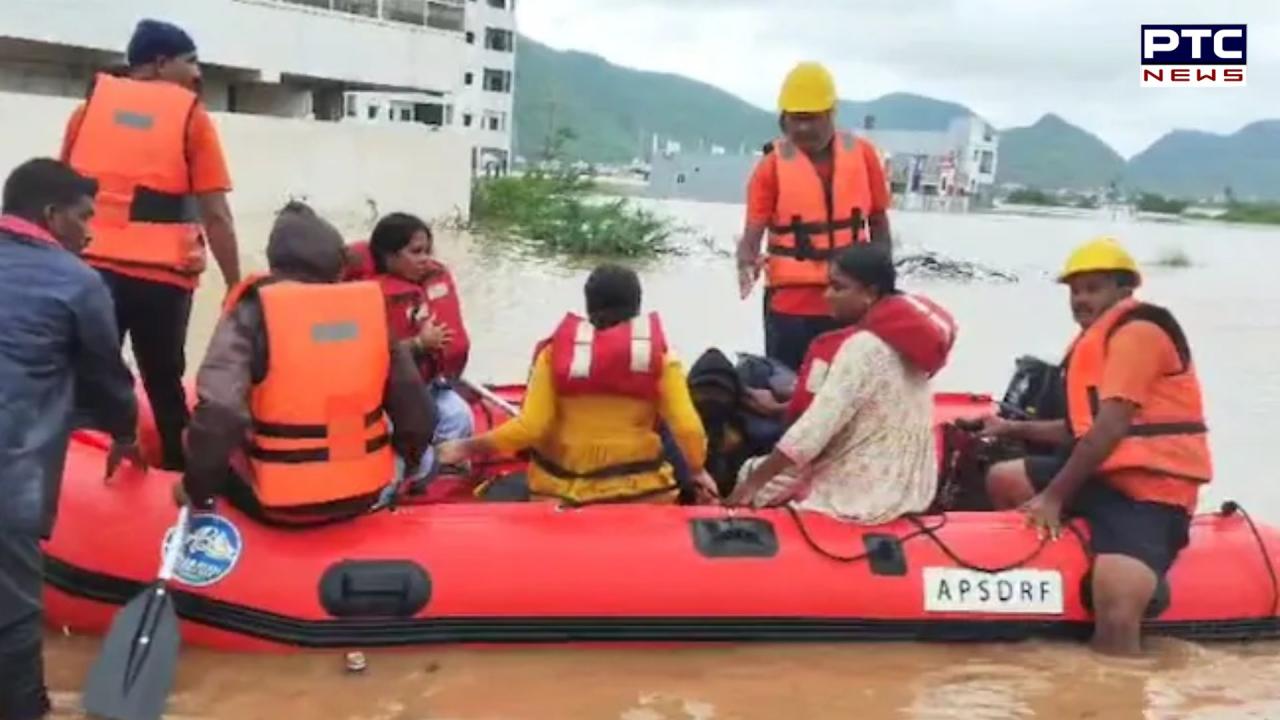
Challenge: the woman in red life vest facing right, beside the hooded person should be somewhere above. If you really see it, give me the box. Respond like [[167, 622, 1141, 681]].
[[347, 213, 475, 442]]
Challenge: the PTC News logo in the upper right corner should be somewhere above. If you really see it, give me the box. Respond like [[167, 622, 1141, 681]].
[[1142, 24, 1247, 87]]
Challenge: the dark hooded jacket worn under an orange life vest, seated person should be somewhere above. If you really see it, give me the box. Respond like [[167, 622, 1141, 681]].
[[183, 210, 435, 514]]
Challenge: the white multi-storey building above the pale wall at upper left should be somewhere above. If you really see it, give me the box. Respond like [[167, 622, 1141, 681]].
[[0, 0, 516, 176]]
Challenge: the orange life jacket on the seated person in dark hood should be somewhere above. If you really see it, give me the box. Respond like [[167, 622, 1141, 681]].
[[248, 281, 394, 507]]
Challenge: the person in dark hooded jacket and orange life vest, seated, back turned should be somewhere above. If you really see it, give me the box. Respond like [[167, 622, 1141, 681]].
[[178, 202, 435, 524]]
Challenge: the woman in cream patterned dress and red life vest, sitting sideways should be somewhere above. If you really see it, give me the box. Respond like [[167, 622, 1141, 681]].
[[727, 245, 956, 523]]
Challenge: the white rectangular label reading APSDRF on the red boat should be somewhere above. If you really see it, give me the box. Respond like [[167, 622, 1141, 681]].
[[924, 568, 1062, 615]]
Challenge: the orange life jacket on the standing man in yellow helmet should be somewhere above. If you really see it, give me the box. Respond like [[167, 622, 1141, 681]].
[[765, 132, 872, 287]]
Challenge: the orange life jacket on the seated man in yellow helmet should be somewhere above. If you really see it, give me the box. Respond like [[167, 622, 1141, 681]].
[[1066, 299, 1213, 483]]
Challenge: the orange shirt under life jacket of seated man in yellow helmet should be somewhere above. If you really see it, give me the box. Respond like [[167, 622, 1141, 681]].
[[1098, 320, 1199, 512]]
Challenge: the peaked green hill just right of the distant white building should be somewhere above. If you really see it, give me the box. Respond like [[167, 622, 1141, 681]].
[[996, 114, 1125, 190]]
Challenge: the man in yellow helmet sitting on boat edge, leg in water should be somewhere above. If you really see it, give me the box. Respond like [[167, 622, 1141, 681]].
[[984, 237, 1213, 655]]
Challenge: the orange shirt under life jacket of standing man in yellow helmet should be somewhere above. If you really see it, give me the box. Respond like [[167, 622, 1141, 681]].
[[746, 140, 891, 316]]
